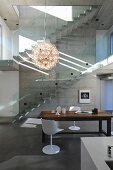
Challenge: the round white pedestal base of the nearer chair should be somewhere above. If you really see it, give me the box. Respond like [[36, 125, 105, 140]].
[[42, 145, 60, 155]]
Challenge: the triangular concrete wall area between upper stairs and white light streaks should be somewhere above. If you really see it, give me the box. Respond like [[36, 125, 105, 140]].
[[58, 23, 96, 64]]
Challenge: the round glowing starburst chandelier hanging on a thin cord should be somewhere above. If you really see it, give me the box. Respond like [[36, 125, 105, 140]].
[[31, 41, 59, 70]]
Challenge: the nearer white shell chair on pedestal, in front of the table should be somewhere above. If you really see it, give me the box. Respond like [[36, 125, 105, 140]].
[[42, 119, 64, 155]]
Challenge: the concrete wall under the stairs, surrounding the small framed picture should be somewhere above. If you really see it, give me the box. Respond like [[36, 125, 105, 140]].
[[49, 75, 96, 110]]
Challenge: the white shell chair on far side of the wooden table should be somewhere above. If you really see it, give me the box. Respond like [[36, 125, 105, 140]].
[[69, 106, 81, 130]]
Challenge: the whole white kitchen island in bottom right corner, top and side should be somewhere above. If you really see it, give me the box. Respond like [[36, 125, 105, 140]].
[[81, 137, 113, 170]]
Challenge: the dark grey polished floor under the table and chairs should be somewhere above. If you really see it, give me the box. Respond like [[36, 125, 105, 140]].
[[0, 122, 107, 170]]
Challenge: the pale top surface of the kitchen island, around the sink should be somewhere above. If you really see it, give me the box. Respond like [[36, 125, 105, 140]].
[[81, 137, 113, 170]]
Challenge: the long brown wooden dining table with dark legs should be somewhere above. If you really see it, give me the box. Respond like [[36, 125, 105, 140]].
[[40, 111, 113, 141]]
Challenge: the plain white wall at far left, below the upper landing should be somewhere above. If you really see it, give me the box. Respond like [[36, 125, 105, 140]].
[[0, 71, 19, 117]]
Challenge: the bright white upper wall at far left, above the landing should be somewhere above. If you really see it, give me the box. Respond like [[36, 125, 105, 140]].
[[0, 17, 13, 60]]
